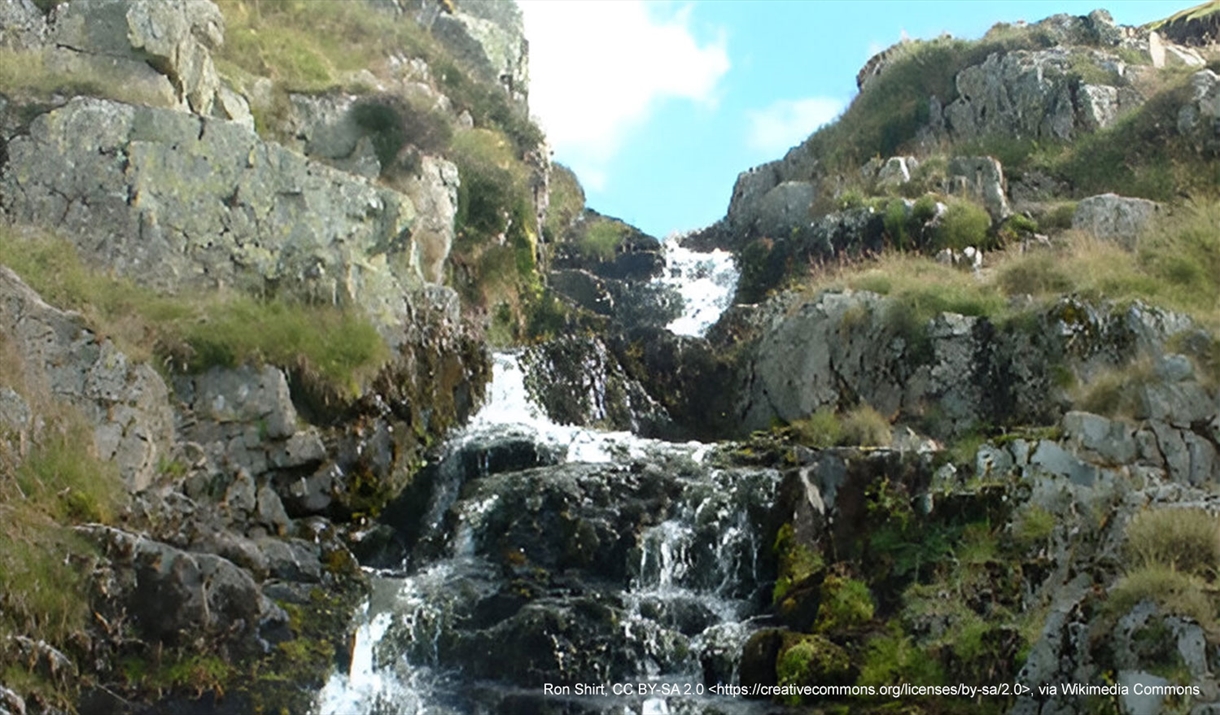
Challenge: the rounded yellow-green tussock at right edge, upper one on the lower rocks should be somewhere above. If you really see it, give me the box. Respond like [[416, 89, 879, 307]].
[[1126, 509, 1220, 578]]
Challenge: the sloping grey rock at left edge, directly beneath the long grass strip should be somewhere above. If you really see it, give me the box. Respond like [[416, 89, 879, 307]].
[[0, 267, 173, 490]]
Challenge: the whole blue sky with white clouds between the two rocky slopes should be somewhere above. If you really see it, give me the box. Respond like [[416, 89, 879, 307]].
[[520, 0, 1193, 237]]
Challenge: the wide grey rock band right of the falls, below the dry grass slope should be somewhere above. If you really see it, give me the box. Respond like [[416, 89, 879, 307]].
[[741, 287, 1191, 437]]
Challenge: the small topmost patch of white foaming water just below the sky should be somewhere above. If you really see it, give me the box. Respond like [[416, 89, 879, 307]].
[[660, 237, 737, 337]]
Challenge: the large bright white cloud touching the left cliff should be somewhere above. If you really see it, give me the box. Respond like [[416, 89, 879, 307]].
[[520, 0, 728, 188]]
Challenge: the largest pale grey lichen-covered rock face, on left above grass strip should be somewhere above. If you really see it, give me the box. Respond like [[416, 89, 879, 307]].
[[0, 99, 448, 338]]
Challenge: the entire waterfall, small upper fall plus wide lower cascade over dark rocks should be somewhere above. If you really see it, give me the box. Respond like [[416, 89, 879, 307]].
[[317, 249, 778, 715]]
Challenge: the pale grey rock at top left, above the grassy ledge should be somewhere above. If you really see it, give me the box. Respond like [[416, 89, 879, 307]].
[[49, 0, 224, 116]]
